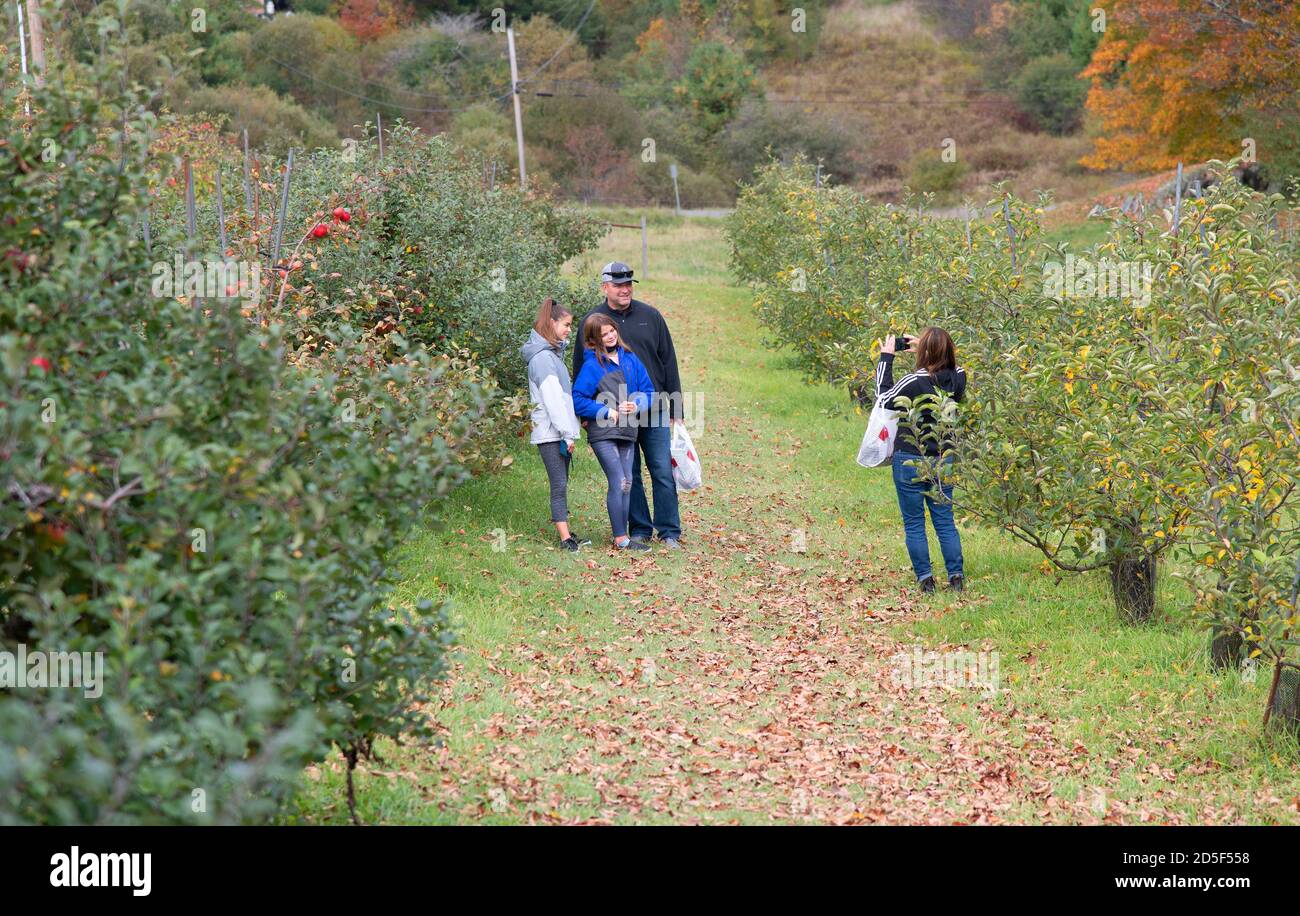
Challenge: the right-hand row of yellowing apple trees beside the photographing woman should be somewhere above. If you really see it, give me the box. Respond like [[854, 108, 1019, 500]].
[[731, 155, 1300, 664]]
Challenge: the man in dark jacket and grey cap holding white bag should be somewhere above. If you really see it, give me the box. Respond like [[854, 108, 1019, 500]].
[[573, 261, 683, 550]]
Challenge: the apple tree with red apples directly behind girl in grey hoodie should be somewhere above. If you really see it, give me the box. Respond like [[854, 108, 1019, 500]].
[[163, 122, 603, 391]]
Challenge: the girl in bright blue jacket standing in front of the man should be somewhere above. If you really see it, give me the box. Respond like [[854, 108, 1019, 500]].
[[573, 314, 654, 551]]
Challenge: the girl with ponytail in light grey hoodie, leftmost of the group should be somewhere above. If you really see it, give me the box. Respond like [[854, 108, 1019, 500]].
[[519, 296, 592, 551]]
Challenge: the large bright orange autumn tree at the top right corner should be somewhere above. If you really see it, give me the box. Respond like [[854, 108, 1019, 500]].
[[1082, 0, 1300, 169]]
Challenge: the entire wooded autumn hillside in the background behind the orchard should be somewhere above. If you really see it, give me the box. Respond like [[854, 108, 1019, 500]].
[[5, 0, 1300, 208]]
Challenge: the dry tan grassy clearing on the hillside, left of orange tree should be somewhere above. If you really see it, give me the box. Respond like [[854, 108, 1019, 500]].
[[764, 0, 1115, 200]]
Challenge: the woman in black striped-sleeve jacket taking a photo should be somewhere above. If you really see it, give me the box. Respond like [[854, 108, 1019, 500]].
[[876, 327, 966, 591]]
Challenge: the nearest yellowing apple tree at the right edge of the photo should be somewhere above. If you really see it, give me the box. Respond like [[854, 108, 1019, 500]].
[[1130, 175, 1300, 712]]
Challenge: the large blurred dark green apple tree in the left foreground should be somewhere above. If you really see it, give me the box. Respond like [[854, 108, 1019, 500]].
[[0, 55, 493, 824]]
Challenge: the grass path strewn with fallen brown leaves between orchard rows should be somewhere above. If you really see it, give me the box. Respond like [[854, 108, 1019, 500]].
[[291, 210, 1300, 824]]
